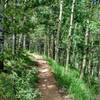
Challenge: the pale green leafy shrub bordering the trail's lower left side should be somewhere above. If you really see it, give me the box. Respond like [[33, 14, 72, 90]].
[[13, 68, 39, 100]]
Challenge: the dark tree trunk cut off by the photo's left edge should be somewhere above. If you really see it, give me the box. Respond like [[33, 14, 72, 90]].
[[0, 1, 4, 70]]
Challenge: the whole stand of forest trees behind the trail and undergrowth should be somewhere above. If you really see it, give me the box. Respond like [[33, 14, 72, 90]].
[[0, 0, 100, 85]]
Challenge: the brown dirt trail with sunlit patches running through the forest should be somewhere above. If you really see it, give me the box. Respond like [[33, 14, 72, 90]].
[[34, 55, 72, 100]]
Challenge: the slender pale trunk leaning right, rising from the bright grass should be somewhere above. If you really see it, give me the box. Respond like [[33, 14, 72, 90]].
[[66, 0, 76, 70]]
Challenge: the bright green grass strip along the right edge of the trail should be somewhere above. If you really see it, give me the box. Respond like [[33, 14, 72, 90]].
[[48, 58, 94, 100]]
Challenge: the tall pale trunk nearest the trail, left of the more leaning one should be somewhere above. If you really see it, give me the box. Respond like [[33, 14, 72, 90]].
[[55, 0, 63, 62]]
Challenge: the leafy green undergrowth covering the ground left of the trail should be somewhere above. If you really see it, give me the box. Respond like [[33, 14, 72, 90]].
[[0, 52, 40, 100]]
